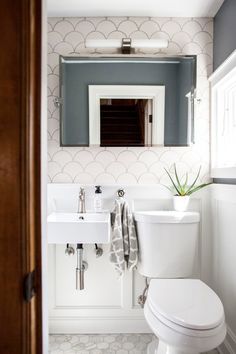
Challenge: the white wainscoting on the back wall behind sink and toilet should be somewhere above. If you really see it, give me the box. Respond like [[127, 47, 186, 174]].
[[48, 184, 210, 333]]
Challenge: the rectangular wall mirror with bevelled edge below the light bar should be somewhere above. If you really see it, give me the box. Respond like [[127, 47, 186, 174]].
[[60, 56, 196, 146]]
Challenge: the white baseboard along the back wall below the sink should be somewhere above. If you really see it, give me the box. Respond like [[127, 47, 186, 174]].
[[49, 317, 152, 334]]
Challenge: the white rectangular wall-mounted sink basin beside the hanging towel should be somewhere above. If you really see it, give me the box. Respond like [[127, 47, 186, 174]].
[[47, 212, 110, 244]]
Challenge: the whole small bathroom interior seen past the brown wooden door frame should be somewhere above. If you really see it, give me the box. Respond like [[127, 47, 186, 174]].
[[0, 0, 236, 354]]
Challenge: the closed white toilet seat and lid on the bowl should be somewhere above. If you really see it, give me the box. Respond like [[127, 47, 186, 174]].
[[147, 279, 224, 335]]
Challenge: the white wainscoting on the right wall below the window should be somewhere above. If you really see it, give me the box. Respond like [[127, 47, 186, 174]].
[[212, 185, 236, 354]]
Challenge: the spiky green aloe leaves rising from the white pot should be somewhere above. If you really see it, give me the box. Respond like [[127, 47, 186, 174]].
[[165, 164, 211, 197]]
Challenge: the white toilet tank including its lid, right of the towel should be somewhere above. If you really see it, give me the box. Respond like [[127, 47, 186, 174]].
[[134, 211, 200, 278]]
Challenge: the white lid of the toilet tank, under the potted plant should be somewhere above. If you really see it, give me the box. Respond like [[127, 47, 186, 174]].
[[134, 210, 200, 224]]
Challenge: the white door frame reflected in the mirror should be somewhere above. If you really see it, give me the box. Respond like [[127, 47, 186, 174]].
[[89, 85, 165, 146]]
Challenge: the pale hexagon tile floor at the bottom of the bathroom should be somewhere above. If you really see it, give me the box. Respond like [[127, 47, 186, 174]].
[[49, 334, 218, 354]]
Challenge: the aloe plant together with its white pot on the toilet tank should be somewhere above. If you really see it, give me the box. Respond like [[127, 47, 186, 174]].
[[165, 164, 211, 211]]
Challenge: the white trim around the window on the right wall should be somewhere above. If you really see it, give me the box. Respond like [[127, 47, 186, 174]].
[[209, 50, 236, 178]]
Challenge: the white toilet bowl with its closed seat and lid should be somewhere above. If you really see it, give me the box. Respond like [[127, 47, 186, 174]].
[[144, 279, 226, 354]]
